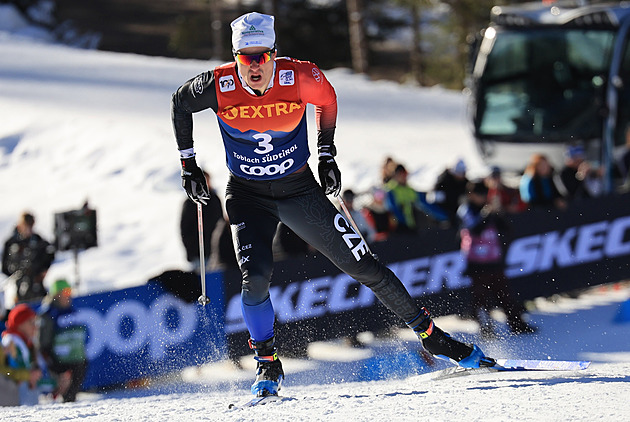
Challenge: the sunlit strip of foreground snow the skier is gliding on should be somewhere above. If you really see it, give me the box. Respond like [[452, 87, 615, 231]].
[[0, 363, 630, 422]]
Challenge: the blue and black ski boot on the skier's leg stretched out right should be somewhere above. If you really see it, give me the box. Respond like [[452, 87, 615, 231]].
[[407, 308, 495, 368]]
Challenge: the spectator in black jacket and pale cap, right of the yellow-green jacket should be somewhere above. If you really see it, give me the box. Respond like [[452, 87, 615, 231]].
[[427, 159, 468, 227]]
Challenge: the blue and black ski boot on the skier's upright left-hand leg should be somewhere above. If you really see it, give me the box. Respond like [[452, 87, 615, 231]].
[[249, 337, 284, 397]]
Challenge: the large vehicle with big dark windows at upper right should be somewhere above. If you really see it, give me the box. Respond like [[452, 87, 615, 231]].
[[467, 1, 630, 192]]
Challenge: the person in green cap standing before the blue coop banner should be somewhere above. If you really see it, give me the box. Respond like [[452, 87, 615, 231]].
[[39, 279, 88, 402]]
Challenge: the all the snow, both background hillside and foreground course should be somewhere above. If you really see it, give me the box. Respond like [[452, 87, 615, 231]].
[[0, 9, 630, 422]]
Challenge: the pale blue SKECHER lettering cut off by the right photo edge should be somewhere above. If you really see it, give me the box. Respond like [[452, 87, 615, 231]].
[[506, 217, 630, 277]]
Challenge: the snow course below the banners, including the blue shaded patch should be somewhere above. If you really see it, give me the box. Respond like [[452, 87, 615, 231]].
[[0, 285, 630, 422]]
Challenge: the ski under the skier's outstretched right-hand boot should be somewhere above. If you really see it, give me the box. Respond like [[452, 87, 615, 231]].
[[433, 359, 591, 380]]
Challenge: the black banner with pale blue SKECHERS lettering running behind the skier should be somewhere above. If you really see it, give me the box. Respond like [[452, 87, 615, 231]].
[[225, 194, 630, 355]]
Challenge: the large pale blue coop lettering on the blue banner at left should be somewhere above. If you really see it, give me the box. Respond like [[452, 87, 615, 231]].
[[66, 294, 198, 360]]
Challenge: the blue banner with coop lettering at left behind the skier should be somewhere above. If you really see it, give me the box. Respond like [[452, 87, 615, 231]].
[[69, 273, 227, 389]]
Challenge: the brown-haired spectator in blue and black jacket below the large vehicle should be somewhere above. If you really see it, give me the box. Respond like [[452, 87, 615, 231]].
[[519, 154, 566, 209]]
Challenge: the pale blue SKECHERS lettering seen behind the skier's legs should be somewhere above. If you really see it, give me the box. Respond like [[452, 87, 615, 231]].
[[225, 251, 470, 334]]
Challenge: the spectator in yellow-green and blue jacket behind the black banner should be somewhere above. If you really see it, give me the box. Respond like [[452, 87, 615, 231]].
[[385, 164, 418, 233]]
